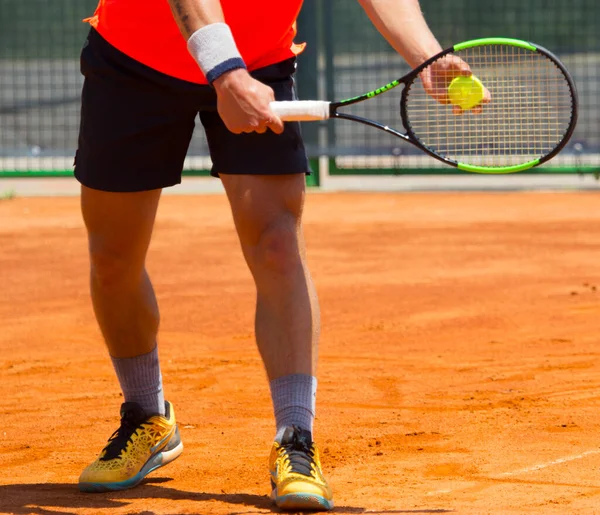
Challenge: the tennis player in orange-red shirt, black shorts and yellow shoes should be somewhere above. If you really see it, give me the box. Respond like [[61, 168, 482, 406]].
[[75, 0, 468, 509]]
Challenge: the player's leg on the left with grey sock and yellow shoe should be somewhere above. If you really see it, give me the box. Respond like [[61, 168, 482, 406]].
[[79, 186, 183, 492]]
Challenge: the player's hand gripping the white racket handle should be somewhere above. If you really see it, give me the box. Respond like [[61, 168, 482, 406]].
[[213, 69, 283, 134]]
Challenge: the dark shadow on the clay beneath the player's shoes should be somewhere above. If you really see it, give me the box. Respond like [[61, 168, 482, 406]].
[[0, 477, 451, 515]]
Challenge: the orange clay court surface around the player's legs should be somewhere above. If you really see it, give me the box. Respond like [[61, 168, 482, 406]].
[[0, 193, 600, 515]]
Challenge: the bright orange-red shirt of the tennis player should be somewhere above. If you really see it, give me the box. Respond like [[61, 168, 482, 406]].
[[84, 0, 303, 84]]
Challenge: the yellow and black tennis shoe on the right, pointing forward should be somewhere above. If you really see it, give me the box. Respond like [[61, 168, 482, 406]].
[[269, 426, 333, 510]]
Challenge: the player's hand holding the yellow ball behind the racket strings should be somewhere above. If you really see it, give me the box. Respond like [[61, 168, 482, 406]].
[[421, 54, 492, 115]]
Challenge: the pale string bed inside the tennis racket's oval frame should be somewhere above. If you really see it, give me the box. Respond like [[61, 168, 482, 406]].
[[406, 45, 573, 168]]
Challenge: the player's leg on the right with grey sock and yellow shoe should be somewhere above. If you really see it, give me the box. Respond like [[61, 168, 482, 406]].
[[221, 174, 333, 509]]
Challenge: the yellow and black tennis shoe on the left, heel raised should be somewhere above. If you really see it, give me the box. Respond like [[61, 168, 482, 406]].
[[79, 402, 183, 492]]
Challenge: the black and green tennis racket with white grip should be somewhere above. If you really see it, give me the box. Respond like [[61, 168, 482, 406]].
[[271, 38, 577, 173]]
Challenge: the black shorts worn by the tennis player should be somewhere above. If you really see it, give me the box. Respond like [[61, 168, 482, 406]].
[[75, 29, 309, 192]]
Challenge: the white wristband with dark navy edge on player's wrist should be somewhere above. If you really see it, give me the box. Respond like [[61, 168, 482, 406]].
[[188, 22, 246, 84]]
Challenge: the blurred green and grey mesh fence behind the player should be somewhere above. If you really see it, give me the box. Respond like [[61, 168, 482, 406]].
[[0, 0, 600, 184]]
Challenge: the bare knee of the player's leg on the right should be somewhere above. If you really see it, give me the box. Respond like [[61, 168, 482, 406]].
[[250, 220, 301, 275]]
